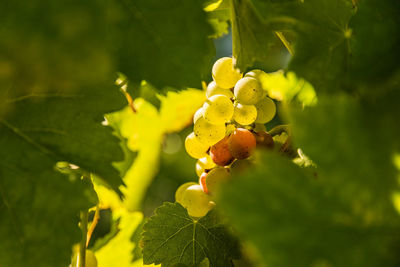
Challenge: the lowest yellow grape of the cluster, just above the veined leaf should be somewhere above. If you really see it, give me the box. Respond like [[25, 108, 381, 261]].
[[179, 184, 213, 217]]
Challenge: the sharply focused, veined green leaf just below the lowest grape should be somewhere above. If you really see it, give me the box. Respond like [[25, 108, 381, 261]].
[[142, 202, 238, 267]]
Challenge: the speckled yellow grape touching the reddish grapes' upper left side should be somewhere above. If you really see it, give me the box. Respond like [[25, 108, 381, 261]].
[[193, 117, 226, 146]]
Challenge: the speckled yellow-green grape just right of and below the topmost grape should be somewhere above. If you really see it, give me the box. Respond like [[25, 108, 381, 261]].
[[234, 77, 267, 105]]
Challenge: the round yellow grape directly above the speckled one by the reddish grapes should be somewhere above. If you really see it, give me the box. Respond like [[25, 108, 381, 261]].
[[203, 95, 234, 125]]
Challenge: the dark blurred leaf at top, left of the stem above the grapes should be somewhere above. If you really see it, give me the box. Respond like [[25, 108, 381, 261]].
[[116, 0, 214, 88]]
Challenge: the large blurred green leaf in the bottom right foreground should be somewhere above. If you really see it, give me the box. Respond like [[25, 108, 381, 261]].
[[217, 154, 400, 267]]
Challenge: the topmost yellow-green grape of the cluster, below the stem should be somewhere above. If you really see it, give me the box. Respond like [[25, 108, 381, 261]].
[[212, 57, 242, 89]]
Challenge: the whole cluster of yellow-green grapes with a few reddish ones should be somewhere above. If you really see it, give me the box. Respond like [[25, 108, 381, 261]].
[[175, 57, 276, 217]]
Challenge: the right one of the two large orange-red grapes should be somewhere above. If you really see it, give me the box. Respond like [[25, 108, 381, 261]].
[[228, 128, 256, 159]]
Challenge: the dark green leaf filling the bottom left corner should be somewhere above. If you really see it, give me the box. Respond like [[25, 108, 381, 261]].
[[0, 130, 95, 267]]
